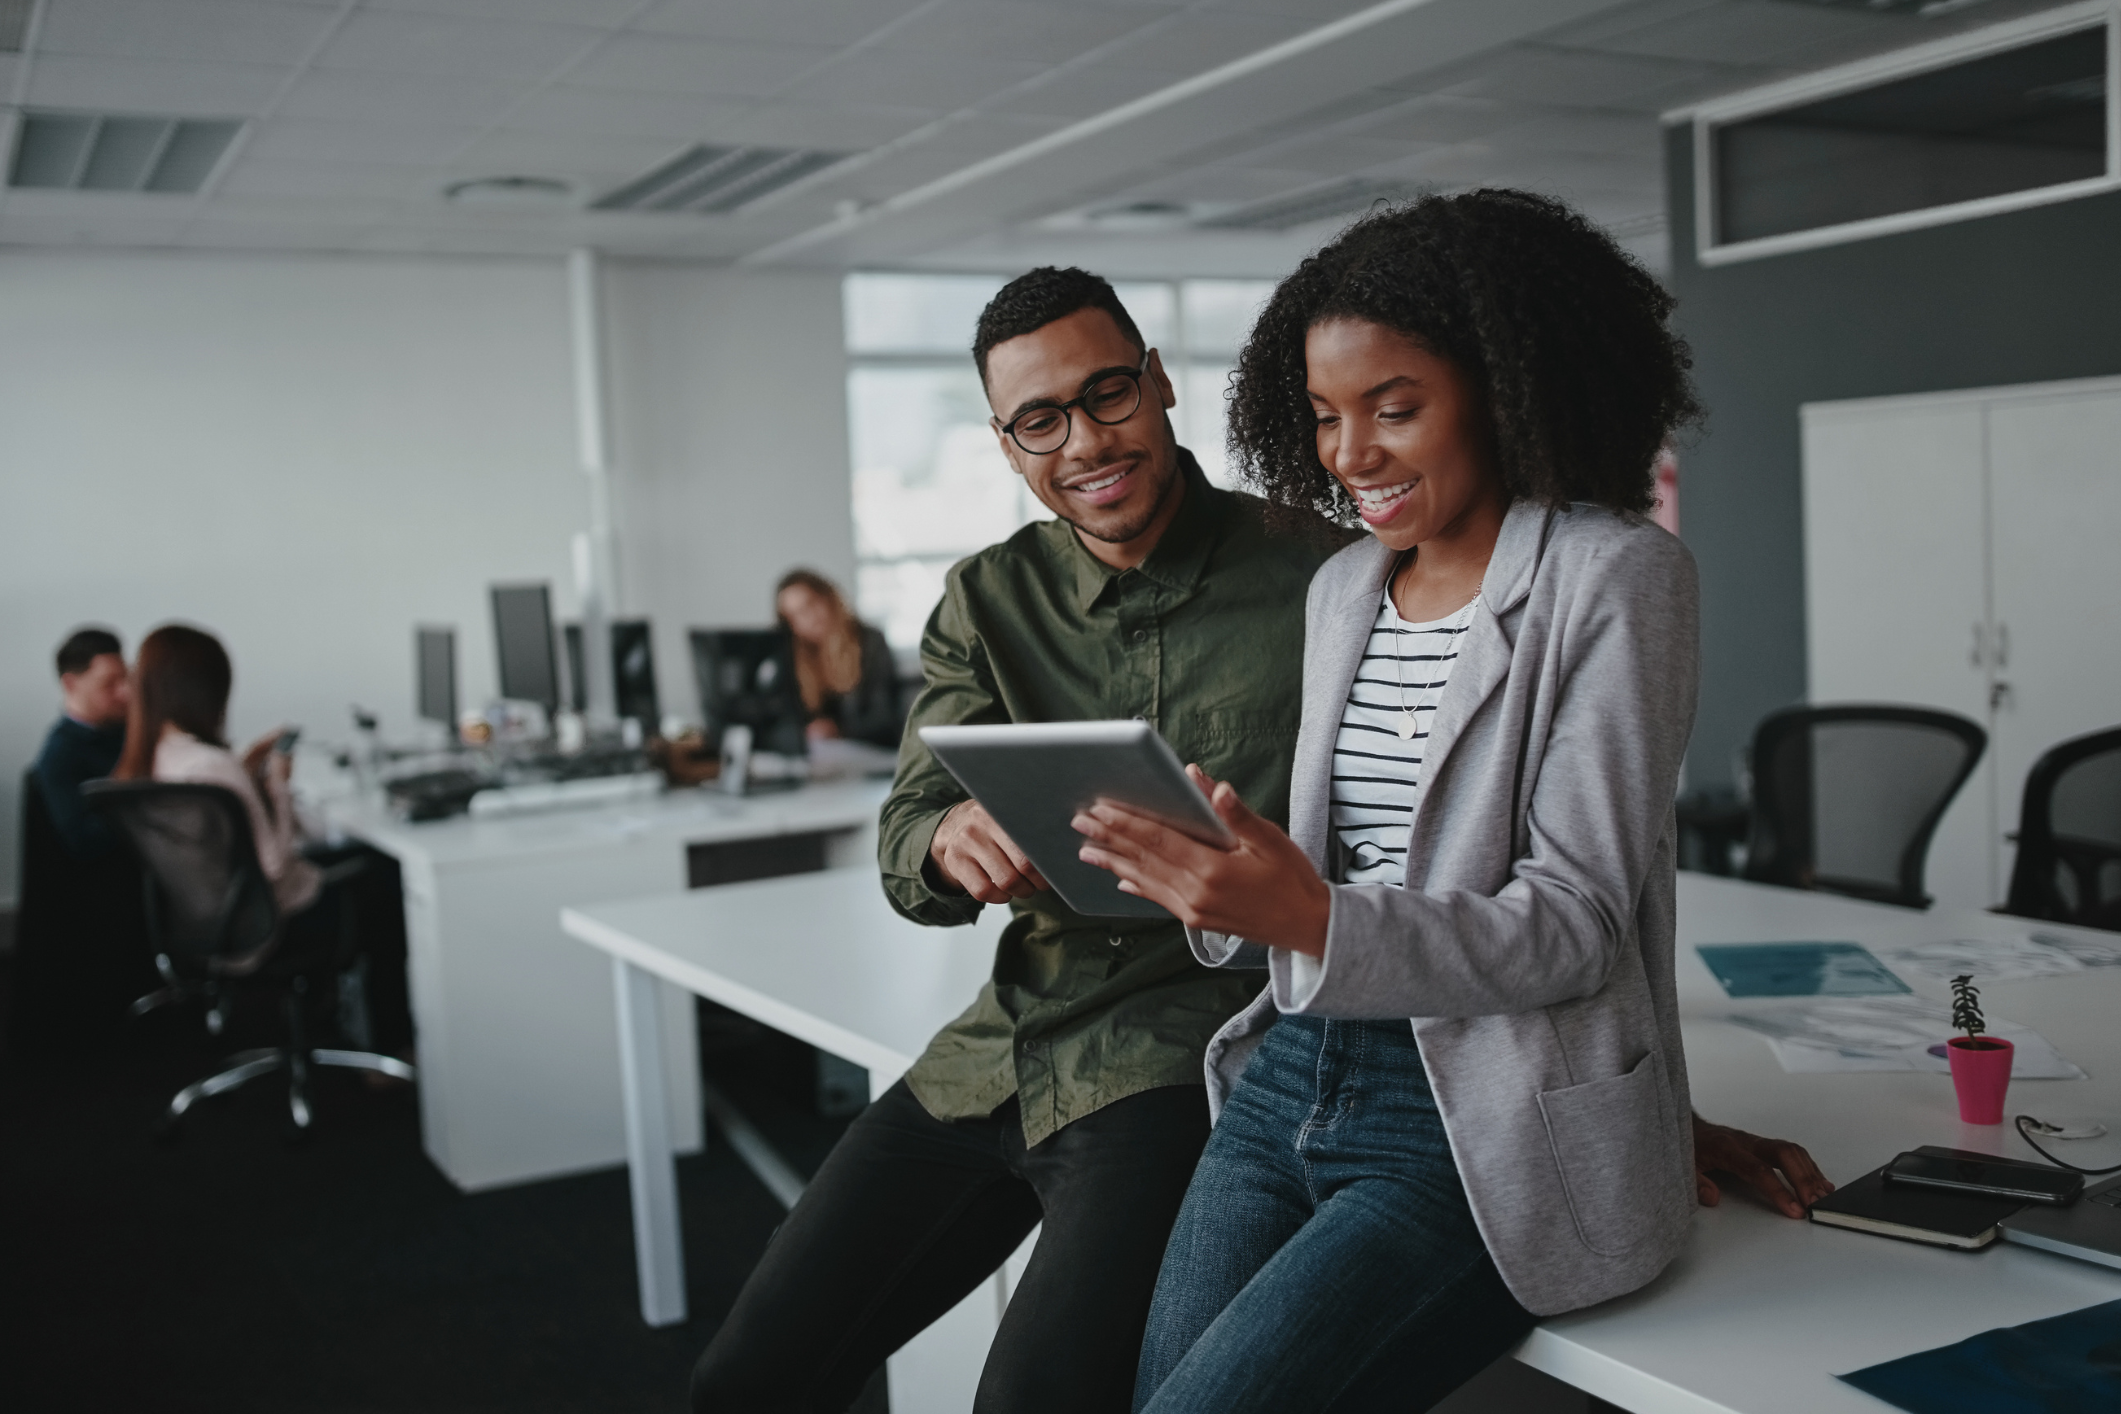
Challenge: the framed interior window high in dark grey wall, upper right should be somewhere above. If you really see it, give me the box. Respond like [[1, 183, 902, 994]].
[[1695, 4, 2121, 265]]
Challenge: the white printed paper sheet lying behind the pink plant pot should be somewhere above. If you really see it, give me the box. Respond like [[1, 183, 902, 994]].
[[1729, 996, 2085, 1079]]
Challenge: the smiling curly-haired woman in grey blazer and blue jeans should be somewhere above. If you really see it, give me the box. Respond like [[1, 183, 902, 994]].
[[1077, 191, 1739, 1414]]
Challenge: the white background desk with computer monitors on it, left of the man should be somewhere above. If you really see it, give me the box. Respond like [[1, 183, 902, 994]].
[[318, 780, 889, 1191]]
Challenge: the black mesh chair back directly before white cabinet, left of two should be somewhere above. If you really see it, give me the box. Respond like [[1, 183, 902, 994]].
[[1746, 706, 1987, 907]]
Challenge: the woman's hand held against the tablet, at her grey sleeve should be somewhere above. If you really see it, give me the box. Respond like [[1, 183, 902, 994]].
[[1073, 765, 1332, 956]]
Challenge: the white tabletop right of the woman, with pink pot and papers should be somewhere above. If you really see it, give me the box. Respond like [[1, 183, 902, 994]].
[[1517, 873, 2121, 1414]]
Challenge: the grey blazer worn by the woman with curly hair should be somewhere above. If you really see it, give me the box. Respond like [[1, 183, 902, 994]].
[[1188, 500, 1699, 1316]]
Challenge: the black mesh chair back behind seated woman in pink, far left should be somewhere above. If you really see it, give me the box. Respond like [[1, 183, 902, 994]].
[[83, 780, 280, 977]]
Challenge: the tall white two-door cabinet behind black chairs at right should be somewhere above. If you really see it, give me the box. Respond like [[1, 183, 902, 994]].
[[1803, 379, 2121, 907]]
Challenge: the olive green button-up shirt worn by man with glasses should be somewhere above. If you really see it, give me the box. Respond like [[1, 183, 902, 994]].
[[880, 452, 1326, 1145]]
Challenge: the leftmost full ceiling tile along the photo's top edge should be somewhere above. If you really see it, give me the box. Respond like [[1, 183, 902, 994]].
[[36, 0, 331, 64]]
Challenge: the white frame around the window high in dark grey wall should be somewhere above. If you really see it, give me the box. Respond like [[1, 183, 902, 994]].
[[1663, 0, 2121, 267]]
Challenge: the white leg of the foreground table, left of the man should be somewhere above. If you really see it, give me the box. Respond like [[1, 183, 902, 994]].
[[611, 958, 685, 1325]]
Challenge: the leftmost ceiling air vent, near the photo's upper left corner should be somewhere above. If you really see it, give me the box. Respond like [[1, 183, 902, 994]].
[[6, 112, 244, 195]]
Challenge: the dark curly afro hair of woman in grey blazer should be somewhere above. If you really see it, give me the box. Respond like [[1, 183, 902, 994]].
[[1230, 191, 1701, 526]]
